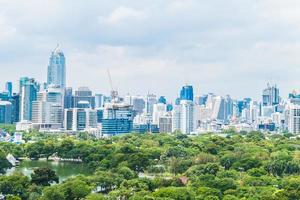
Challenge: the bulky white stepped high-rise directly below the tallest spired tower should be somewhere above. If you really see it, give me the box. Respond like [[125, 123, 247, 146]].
[[32, 85, 63, 129]]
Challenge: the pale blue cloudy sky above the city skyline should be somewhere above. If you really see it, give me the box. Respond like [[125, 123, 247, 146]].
[[0, 0, 300, 99]]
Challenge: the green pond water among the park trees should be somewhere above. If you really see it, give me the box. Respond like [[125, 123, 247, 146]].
[[6, 160, 92, 182]]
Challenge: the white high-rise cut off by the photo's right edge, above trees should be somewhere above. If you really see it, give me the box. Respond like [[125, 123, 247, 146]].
[[288, 104, 300, 134]]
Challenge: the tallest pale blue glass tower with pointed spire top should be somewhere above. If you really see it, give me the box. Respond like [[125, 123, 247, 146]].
[[47, 45, 66, 89]]
